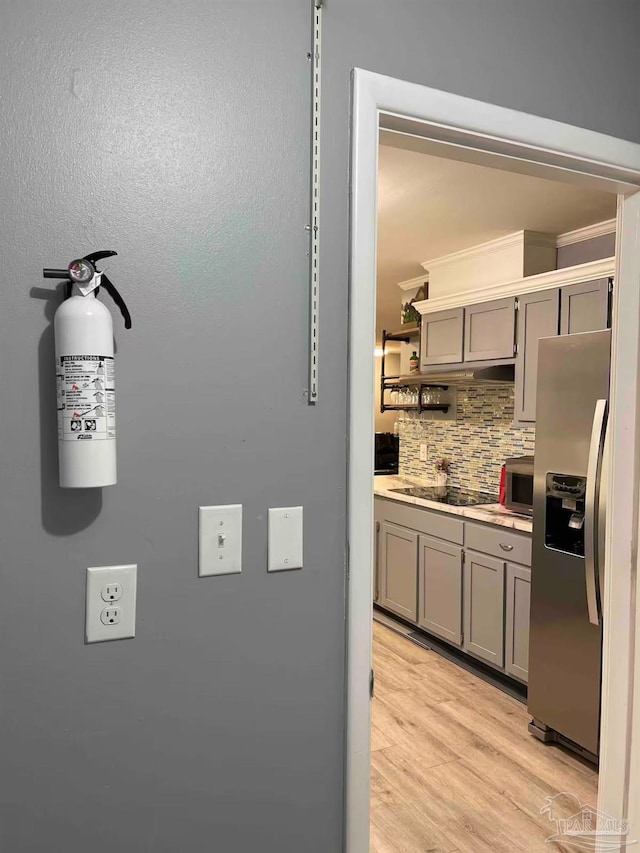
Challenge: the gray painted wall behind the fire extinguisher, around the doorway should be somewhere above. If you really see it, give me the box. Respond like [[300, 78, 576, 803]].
[[0, 0, 640, 853]]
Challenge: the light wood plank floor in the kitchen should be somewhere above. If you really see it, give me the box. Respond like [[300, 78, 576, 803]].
[[371, 623, 598, 853]]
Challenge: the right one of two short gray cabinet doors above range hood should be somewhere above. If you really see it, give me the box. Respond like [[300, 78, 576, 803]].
[[464, 296, 516, 361]]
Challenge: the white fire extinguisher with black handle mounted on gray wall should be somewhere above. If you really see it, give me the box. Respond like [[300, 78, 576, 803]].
[[42, 251, 131, 489]]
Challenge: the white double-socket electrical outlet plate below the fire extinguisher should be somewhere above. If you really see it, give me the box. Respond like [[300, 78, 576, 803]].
[[85, 565, 138, 643]]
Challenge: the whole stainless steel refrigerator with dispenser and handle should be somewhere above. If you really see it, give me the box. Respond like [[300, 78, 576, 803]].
[[528, 331, 611, 758]]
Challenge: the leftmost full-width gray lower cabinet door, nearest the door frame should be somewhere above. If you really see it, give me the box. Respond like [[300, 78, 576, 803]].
[[379, 521, 418, 622]]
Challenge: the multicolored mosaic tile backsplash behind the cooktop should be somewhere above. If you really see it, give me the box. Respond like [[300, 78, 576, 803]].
[[399, 385, 535, 494]]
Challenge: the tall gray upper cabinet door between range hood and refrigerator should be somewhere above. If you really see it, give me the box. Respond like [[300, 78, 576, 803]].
[[514, 288, 560, 423]]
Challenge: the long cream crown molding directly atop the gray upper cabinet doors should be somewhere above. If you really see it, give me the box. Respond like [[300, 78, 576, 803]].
[[413, 257, 616, 315]]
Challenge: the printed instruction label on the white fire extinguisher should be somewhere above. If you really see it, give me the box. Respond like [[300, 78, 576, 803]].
[[56, 355, 116, 441]]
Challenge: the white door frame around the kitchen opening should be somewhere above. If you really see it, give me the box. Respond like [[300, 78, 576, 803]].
[[345, 69, 640, 853]]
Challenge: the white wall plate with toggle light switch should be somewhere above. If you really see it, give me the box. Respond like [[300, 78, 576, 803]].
[[198, 504, 242, 578]]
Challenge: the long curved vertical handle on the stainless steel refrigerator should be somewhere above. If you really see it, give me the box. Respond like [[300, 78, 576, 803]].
[[584, 400, 607, 625]]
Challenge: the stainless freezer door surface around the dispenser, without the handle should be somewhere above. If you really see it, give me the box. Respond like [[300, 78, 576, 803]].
[[528, 331, 611, 754]]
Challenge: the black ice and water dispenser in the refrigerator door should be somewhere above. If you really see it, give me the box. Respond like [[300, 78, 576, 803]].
[[544, 474, 587, 557]]
